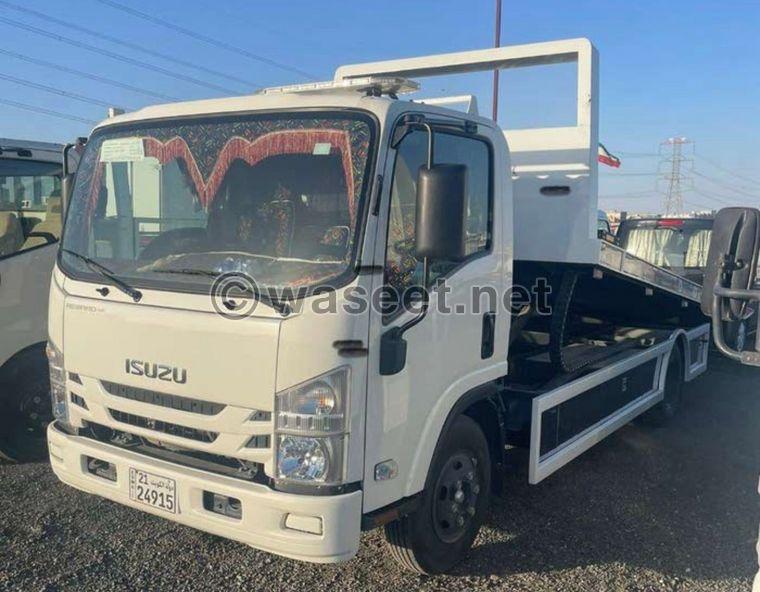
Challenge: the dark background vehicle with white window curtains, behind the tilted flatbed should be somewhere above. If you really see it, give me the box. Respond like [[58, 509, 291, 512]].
[[617, 218, 713, 284]]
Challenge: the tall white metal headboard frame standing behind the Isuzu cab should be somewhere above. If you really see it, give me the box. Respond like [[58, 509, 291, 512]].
[[335, 39, 599, 264]]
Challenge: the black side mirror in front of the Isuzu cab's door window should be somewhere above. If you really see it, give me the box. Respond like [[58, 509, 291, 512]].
[[415, 164, 467, 261]]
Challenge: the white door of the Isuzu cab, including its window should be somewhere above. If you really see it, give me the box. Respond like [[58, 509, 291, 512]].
[[365, 118, 512, 511]]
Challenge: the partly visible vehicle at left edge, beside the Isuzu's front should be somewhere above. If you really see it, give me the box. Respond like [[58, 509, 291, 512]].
[[0, 139, 63, 458]]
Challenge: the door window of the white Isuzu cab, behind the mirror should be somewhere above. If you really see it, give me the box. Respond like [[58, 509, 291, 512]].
[[385, 131, 492, 295]]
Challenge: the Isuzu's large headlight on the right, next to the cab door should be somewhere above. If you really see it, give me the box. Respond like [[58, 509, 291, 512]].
[[275, 367, 350, 485]]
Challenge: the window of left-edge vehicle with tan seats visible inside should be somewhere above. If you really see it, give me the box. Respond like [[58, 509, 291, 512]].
[[0, 159, 63, 257]]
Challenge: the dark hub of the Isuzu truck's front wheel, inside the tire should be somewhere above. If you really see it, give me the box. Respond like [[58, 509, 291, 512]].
[[433, 453, 480, 543]]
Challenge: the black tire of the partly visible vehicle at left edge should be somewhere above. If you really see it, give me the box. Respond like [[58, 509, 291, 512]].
[[0, 348, 53, 462]]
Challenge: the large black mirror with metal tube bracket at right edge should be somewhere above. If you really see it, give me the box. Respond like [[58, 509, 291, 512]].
[[701, 208, 760, 365]]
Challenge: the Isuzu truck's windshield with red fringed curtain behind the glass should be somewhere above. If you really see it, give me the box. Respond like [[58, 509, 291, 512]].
[[61, 112, 375, 291]]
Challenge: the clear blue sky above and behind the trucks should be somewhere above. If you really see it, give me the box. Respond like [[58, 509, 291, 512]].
[[0, 0, 760, 213]]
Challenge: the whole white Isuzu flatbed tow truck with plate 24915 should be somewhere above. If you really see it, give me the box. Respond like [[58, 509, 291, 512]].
[[48, 39, 709, 573]]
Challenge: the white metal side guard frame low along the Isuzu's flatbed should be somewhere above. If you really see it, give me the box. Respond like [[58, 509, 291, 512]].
[[528, 324, 710, 484]]
